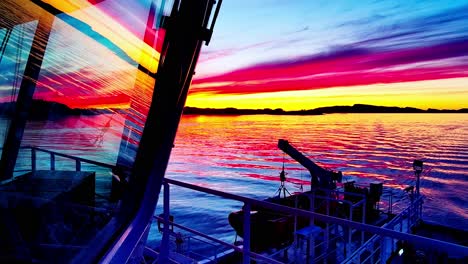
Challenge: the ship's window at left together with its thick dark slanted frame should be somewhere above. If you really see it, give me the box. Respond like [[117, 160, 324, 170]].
[[0, 0, 219, 263]]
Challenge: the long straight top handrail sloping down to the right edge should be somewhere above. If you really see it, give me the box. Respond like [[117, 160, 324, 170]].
[[164, 178, 468, 257]]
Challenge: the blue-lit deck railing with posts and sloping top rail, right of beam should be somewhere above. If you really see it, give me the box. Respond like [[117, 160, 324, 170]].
[[150, 178, 468, 263]]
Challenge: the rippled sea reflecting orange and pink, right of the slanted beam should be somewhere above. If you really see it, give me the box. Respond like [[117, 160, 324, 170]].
[[158, 114, 468, 242]]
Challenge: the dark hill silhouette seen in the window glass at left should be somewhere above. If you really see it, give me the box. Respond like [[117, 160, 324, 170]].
[[0, 100, 111, 120]]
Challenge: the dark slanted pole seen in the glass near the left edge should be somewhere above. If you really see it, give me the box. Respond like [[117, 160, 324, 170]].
[[0, 11, 54, 180]]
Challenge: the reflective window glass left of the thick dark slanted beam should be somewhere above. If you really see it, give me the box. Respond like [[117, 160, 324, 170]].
[[0, 0, 170, 263]]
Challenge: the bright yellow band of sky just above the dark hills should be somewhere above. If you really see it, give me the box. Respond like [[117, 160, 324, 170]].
[[186, 78, 468, 110]]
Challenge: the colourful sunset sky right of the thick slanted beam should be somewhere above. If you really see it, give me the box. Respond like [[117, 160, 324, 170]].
[[187, 0, 468, 110]]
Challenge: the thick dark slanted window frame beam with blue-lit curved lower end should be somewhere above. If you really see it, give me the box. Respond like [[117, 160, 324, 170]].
[[101, 0, 219, 263]]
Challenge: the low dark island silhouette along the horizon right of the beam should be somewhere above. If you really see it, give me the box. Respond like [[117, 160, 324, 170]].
[[184, 104, 468, 115]]
